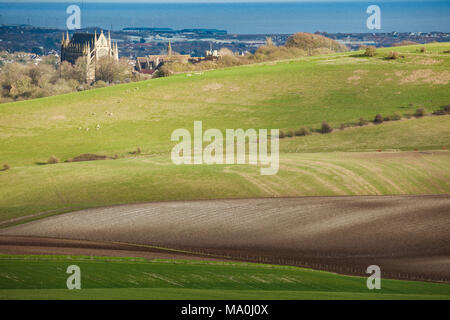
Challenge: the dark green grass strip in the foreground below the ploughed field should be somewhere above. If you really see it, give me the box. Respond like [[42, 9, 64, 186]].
[[0, 256, 450, 300]]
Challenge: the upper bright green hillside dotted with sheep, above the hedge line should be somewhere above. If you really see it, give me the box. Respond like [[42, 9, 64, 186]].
[[0, 44, 450, 166]]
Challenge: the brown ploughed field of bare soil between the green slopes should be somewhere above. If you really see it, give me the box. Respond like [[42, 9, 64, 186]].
[[0, 195, 450, 282]]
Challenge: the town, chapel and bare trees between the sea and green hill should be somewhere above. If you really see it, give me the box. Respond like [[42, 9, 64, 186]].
[[0, 25, 450, 103]]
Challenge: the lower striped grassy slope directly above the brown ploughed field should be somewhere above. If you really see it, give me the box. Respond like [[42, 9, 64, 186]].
[[0, 151, 450, 221]]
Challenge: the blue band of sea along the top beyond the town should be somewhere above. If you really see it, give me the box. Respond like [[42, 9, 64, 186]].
[[0, 0, 450, 34]]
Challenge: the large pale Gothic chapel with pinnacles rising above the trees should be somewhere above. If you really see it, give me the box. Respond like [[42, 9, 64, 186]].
[[61, 31, 119, 81]]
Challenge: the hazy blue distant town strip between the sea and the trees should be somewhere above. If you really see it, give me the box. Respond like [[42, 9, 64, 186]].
[[0, 25, 450, 60]]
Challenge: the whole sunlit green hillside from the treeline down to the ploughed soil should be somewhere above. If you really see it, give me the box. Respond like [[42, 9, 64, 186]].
[[0, 44, 450, 221]]
